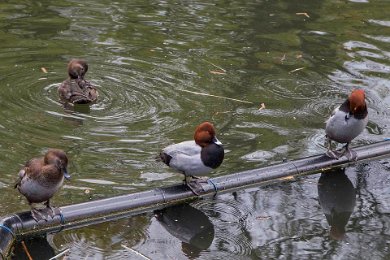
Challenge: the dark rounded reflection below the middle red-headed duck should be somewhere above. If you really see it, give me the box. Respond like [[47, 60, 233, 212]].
[[155, 204, 214, 258]]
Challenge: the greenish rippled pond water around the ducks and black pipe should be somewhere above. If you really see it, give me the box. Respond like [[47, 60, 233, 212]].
[[0, 0, 390, 259]]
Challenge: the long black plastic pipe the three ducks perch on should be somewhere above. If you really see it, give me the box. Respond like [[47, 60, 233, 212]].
[[0, 142, 390, 258]]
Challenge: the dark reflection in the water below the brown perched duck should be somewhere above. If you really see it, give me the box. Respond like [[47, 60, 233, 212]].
[[12, 237, 56, 260]]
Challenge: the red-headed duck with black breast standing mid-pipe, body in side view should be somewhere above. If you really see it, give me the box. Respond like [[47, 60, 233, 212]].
[[160, 121, 225, 195]]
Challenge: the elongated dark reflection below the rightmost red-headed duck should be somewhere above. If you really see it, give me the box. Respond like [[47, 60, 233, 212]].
[[318, 169, 356, 240]]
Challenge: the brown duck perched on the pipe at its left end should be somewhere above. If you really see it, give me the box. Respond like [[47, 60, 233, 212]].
[[14, 149, 70, 222]]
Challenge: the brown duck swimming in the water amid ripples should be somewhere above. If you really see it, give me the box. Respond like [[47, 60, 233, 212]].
[[58, 59, 99, 104]]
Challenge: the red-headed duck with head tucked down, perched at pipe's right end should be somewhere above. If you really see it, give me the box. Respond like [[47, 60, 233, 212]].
[[325, 89, 368, 160]]
